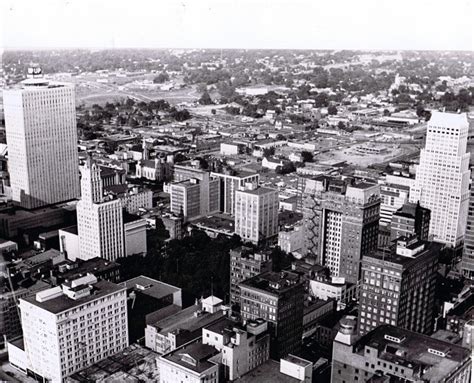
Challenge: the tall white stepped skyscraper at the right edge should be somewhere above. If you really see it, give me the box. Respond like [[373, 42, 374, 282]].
[[410, 112, 470, 247]]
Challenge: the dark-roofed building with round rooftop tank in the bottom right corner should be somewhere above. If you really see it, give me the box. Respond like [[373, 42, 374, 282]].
[[331, 317, 471, 383]]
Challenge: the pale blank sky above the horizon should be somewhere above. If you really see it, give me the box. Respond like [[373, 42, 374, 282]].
[[0, 0, 474, 50]]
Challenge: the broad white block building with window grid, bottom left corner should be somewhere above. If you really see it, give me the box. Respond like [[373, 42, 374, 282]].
[[18, 274, 128, 382]]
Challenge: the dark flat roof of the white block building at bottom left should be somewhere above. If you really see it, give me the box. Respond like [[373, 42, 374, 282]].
[[22, 280, 125, 314]]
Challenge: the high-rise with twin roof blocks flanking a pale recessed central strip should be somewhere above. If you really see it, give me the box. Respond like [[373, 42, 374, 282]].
[[303, 176, 380, 283]]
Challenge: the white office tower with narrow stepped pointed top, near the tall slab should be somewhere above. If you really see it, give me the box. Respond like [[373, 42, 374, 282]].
[[76, 157, 125, 261]]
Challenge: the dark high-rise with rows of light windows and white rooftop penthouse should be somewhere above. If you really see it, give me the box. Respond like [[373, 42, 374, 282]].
[[358, 236, 441, 334]]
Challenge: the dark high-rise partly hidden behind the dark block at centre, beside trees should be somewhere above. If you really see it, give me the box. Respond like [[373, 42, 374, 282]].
[[230, 247, 272, 305]]
